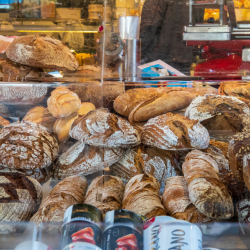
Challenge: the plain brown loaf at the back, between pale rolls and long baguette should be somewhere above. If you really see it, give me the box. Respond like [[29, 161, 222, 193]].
[[69, 80, 125, 109]]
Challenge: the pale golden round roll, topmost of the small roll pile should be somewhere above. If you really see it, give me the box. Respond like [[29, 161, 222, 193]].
[[47, 87, 81, 118]]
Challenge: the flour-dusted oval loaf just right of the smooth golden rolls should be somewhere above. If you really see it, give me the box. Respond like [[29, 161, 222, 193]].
[[70, 108, 140, 148]]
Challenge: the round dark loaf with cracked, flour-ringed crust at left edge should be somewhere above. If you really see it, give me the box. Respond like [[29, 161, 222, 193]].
[[0, 121, 59, 182]]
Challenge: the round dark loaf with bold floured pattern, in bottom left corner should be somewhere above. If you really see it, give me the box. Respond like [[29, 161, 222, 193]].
[[0, 170, 42, 234]]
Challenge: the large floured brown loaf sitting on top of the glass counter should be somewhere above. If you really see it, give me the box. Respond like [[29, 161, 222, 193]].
[[6, 35, 78, 71]]
